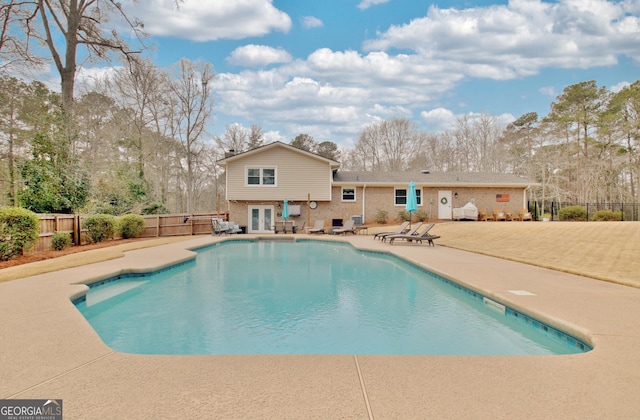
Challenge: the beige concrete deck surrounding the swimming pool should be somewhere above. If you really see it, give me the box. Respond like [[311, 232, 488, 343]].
[[0, 235, 640, 419]]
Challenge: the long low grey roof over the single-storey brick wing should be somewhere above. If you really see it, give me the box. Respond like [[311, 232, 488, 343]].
[[333, 171, 538, 188]]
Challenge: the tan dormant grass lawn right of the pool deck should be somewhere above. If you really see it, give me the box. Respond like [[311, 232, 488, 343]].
[[424, 222, 640, 287]]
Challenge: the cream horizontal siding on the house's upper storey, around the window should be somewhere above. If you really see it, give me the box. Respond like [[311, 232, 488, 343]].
[[226, 147, 332, 201]]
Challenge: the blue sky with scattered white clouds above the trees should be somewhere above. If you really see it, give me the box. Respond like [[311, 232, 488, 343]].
[[85, 0, 640, 147]]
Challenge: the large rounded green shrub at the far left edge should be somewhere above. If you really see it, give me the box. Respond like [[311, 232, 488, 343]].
[[0, 207, 40, 260]]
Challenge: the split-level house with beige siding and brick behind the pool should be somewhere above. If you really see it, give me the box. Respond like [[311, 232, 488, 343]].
[[218, 142, 535, 233]]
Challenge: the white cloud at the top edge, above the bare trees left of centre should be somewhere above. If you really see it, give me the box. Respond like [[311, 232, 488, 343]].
[[124, 0, 291, 41]]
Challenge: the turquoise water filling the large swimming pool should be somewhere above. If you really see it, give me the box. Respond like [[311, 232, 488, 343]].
[[76, 240, 589, 355]]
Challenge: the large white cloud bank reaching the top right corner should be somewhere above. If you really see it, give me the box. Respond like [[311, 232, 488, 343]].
[[364, 0, 640, 79]]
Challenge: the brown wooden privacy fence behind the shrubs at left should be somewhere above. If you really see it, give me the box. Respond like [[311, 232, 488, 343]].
[[28, 213, 229, 254]]
